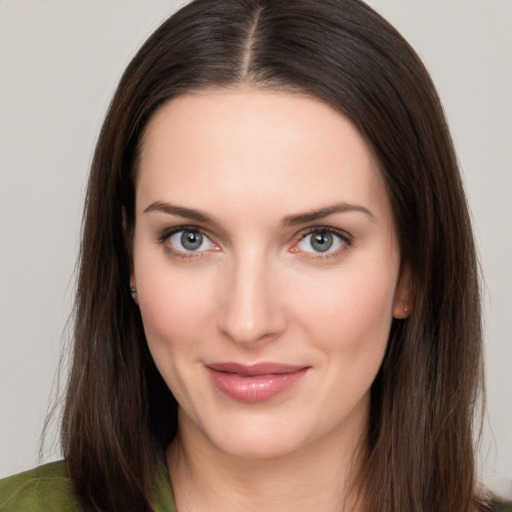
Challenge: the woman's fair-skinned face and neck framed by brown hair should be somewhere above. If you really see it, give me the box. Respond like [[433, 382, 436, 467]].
[[130, 86, 410, 512]]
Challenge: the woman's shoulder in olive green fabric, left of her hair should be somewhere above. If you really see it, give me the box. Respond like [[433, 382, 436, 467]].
[[0, 461, 80, 512]]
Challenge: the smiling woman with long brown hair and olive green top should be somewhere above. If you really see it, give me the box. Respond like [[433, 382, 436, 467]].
[[0, 0, 506, 512]]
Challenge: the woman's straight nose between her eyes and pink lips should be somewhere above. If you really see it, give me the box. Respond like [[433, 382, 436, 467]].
[[217, 251, 286, 345]]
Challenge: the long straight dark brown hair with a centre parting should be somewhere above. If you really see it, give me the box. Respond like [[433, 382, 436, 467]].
[[62, 0, 482, 512]]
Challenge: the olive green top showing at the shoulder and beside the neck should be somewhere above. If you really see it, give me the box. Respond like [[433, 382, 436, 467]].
[[0, 461, 176, 512]]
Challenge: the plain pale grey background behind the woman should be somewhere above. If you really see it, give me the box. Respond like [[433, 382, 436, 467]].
[[0, 0, 512, 497]]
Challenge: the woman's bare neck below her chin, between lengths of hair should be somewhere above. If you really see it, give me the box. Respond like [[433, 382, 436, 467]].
[[167, 412, 361, 512]]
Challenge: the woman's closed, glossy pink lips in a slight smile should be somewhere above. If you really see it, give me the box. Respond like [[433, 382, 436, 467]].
[[206, 362, 310, 403]]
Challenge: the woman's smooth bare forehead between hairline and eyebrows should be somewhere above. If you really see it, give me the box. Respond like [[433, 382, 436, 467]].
[[137, 87, 389, 224]]
